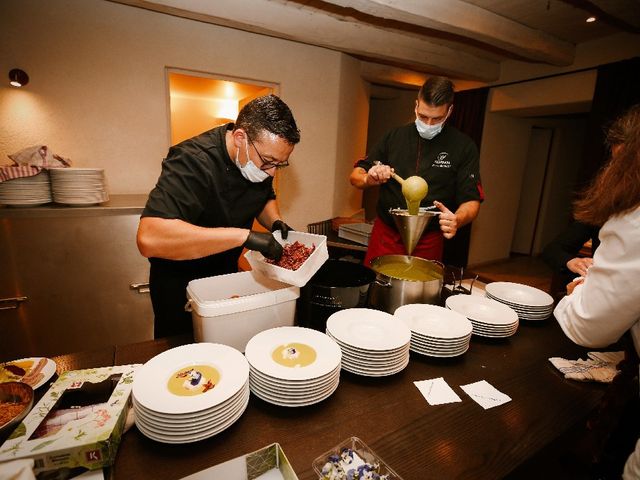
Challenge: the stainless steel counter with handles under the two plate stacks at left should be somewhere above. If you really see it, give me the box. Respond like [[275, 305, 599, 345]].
[[0, 195, 153, 360]]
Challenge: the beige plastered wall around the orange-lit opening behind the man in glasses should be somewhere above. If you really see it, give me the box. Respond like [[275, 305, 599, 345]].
[[0, 0, 366, 228]]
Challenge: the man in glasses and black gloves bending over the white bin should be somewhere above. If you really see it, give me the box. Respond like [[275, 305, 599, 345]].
[[137, 95, 300, 338]]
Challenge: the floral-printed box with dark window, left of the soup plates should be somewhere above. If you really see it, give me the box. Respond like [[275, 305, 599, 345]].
[[0, 365, 140, 474]]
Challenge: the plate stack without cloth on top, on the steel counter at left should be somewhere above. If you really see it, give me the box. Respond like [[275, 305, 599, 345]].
[[49, 168, 109, 205]]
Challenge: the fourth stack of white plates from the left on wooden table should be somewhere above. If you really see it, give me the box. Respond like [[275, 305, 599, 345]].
[[394, 303, 473, 357]]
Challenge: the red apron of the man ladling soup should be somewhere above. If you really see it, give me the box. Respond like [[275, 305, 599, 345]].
[[364, 218, 444, 266]]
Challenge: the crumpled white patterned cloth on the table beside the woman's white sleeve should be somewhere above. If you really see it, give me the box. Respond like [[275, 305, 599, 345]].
[[549, 352, 624, 383]]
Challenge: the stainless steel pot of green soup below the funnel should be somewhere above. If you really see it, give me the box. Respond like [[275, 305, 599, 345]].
[[369, 255, 444, 313]]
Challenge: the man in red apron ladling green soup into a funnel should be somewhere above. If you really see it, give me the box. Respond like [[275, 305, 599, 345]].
[[350, 77, 483, 264]]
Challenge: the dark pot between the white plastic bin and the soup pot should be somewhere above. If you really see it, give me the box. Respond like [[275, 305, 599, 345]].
[[298, 260, 376, 332]]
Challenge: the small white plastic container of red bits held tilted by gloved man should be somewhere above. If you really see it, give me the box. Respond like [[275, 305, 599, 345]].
[[244, 230, 329, 287]]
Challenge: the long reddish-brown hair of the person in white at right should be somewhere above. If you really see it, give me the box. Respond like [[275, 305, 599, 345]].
[[574, 104, 640, 226]]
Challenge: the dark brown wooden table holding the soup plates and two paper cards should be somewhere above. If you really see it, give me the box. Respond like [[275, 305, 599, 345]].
[[55, 319, 605, 480]]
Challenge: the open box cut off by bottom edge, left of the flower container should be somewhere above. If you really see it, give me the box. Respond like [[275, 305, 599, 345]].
[[182, 443, 298, 480]]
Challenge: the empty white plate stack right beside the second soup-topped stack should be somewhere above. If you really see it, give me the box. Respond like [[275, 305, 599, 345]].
[[327, 308, 411, 377]]
